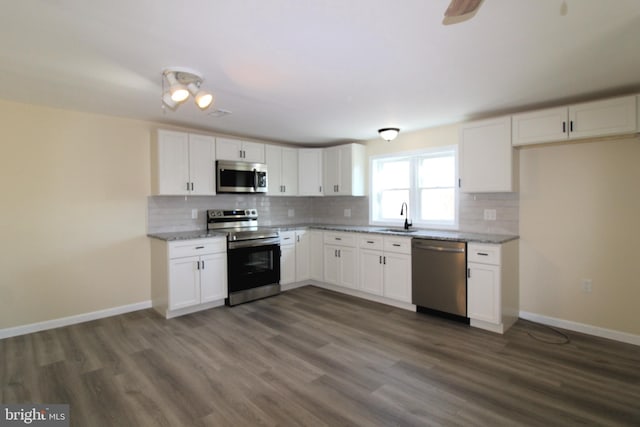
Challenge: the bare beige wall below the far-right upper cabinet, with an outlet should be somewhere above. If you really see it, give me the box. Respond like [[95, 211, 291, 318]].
[[520, 137, 640, 334]]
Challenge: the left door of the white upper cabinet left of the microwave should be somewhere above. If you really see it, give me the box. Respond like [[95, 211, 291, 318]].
[[155, 130, 189, 195]]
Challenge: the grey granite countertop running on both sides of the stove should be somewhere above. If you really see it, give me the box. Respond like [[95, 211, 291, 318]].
[[147, 224, 519, 244]]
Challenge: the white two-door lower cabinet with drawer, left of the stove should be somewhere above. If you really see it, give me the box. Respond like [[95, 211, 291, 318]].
[[151, 237, 227, 318]]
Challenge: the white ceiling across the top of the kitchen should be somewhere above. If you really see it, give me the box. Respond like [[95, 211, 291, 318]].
[[0, 0, 640, 144]]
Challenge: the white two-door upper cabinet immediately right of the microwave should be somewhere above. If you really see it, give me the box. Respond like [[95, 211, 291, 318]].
[[265, 145, 298, 196]]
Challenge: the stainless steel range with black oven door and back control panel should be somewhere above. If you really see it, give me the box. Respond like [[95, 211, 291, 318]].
[[207, 209, 280, 305]]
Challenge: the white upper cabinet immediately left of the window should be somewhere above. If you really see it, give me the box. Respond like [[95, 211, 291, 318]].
[[324, 144, 365, 196]]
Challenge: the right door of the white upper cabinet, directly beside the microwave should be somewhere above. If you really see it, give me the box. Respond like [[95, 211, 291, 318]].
[[189, 135, 216, 196]]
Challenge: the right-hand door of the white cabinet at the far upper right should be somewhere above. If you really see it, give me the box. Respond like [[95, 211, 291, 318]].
[[569, 96, 637, 138]]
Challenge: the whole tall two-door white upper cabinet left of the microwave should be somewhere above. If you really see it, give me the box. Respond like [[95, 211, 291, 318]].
[[151, 130, 216, 196]]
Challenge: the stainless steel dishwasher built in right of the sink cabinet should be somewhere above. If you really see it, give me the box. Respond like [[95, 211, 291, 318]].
[[411, 239, 469, 323]]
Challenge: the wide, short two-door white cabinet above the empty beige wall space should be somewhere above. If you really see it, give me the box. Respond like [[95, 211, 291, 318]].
[[512, 96, 638, 146]]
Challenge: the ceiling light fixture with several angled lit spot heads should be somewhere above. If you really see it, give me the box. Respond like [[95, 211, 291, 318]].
[[162, 68, 213, 110]]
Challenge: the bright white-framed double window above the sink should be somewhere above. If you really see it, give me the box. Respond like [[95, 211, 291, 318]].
[[370, 146, 458, 228]]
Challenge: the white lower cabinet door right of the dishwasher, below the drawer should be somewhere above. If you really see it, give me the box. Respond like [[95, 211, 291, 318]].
[[467, 262, 501, 324]]
